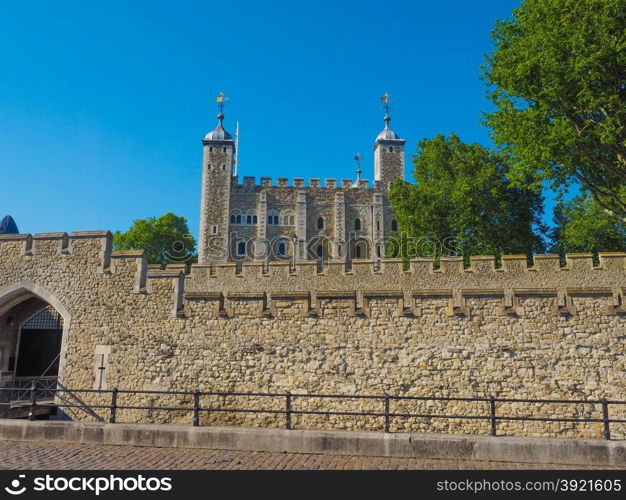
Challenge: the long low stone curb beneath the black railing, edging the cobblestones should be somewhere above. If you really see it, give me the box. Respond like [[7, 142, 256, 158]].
[[0, 419, 626, 467]]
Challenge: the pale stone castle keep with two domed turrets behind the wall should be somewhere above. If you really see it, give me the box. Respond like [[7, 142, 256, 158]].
[[199, 104, 406, 263]]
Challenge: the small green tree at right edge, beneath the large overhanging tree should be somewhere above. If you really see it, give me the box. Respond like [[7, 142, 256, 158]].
[[551, 193, 626, 255]]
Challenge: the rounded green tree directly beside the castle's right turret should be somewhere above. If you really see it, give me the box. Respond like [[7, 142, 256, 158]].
[[390, 134, 544, 257]]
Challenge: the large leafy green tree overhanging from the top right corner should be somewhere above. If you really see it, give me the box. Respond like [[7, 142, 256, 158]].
[[484, 0, 626, 220]]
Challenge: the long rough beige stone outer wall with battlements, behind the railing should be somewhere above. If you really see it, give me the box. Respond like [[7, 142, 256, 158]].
[[0, 232, 626, 438]]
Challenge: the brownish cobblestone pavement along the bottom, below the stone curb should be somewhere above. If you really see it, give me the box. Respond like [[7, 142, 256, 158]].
[[0, 441, 620, 470]]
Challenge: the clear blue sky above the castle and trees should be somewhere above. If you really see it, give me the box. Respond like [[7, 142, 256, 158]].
[[0, 0, 519, 238]]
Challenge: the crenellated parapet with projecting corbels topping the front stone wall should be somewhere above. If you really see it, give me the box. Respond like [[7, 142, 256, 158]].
[[0, 231, 626, 318]]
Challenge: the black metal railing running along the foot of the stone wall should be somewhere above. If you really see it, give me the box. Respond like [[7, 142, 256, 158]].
[[0, 383, 626, 439]]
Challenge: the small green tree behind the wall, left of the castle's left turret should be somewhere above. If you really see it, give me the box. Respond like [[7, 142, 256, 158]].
[[113, 212, 196, 264]]
